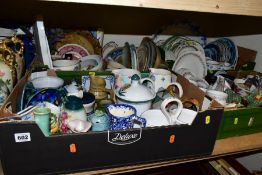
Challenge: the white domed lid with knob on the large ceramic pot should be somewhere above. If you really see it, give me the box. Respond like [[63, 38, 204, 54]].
[[116, 74, 156, 102]]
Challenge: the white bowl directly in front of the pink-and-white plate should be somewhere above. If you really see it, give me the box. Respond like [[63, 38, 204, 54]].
[[53, 60, 80, 71]]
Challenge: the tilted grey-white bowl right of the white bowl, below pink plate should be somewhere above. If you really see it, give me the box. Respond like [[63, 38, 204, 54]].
[[80, 55, 103, 71]]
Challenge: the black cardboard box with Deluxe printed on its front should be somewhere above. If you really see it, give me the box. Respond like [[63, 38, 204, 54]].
[[0, 71, 223, 175]]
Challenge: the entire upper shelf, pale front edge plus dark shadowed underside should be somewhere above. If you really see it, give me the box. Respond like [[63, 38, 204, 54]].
[[0, 0, 262, 37]]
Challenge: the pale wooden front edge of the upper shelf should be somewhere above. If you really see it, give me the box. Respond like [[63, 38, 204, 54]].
[[43, 0, 262, 16]]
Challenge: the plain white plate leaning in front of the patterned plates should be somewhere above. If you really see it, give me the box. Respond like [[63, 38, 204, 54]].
[[172, 51, 207, 79]]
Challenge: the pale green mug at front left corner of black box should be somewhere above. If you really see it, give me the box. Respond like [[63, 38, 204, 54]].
[[33, 107, 51, 136]]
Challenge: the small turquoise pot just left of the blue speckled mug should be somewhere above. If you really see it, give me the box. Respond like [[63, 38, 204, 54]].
[[88, 110, 109, 131]]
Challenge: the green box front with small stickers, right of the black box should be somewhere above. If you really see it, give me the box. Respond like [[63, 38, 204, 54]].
[[217, 107, 262, 139]]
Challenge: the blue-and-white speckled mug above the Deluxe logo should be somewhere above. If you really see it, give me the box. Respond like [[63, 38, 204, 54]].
[[106, 104, 146, 130]]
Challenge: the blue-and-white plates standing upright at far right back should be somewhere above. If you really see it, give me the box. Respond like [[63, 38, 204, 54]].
[[204, 38, 238, 70]]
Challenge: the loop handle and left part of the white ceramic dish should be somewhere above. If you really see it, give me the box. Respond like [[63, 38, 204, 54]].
[[141, 97, 183, 127]]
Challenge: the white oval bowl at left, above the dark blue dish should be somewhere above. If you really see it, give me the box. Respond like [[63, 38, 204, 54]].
[[32, 76, 64, 89]]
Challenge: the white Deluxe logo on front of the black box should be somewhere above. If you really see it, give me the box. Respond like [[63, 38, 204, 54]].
[[108, 128, 142, 145]]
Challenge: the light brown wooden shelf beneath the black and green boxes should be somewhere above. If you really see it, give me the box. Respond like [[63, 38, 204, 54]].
[[70, 132, 262, 175]]
